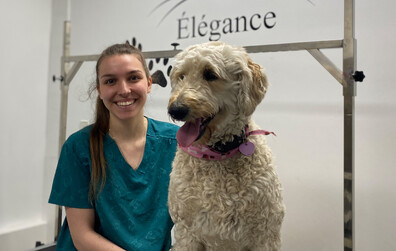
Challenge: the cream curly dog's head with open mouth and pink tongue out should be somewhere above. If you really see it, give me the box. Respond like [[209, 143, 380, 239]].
[[168, 42, 268, 146]]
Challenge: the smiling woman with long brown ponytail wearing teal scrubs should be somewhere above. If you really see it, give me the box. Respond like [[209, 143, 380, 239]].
[[49, 43, 178, 251]]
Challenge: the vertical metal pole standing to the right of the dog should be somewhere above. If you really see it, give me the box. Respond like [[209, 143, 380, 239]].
[[343, 0, 356, 251]]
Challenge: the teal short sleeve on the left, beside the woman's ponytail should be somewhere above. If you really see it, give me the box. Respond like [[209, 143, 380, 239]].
[[49, 133, 92, 208]]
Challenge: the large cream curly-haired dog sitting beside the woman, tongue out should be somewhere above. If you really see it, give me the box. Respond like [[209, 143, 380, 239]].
[[168, 42, 285, 251]]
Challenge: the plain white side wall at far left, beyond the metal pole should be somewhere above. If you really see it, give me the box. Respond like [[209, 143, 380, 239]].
[[0, 0, 51, 250]]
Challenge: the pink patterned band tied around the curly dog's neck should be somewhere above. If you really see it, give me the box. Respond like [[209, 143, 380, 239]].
[[179, 126, 276, 160]]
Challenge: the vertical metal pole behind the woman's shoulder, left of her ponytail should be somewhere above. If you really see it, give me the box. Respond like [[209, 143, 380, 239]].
[[55, 21, 70, 241]]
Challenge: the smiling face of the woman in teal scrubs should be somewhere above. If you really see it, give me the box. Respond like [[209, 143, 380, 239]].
[[98, 54, 152, 120]]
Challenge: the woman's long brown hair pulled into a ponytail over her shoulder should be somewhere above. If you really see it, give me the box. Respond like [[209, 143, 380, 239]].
[[89, 42, 150, 202]]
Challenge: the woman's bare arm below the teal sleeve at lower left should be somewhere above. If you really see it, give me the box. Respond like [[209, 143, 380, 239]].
[[66, 207, 124, 251]]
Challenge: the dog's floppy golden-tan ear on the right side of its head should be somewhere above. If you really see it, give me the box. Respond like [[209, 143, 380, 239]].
[[243, 57, 268, 116]]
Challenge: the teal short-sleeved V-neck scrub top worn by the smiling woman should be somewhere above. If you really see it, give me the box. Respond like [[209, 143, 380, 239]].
[[49, 118, 178, 251]]
